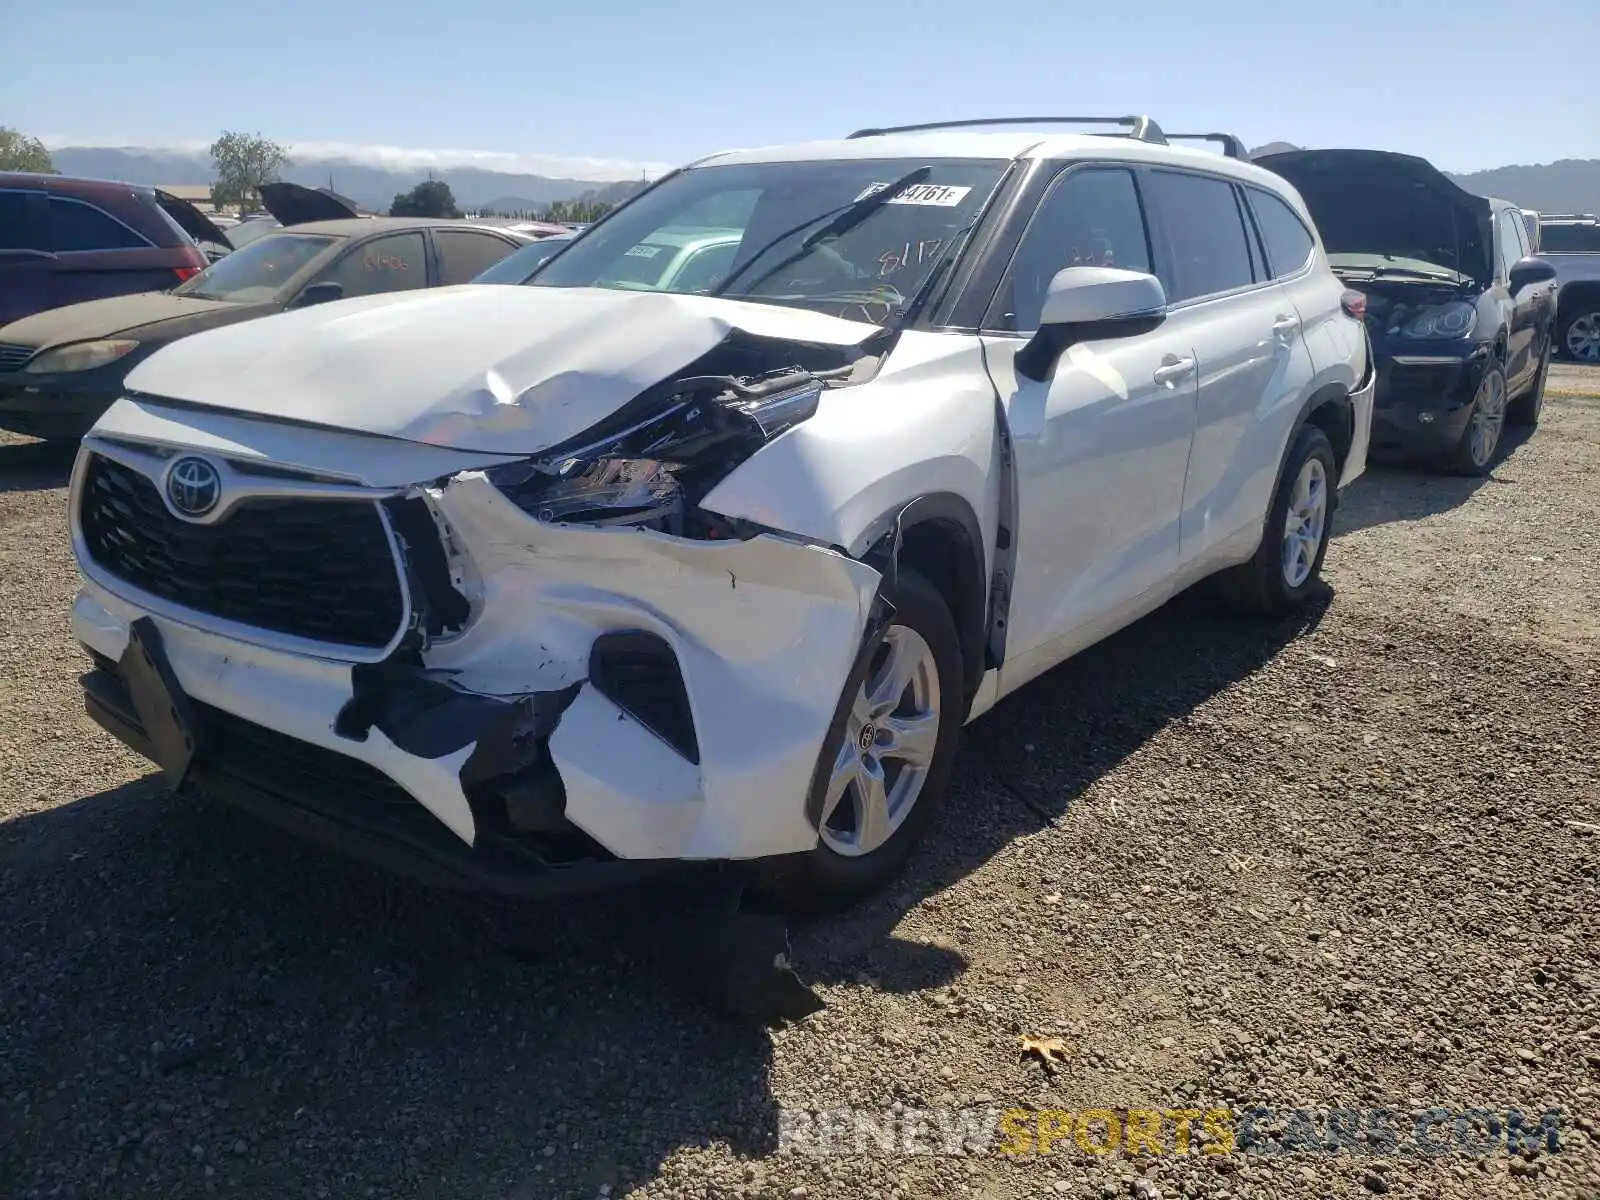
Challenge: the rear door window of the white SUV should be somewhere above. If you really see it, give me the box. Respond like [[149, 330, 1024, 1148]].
[[1150, 171, 1254, 304]]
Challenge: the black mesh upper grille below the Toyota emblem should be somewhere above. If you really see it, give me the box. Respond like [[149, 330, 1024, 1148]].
[[80, 454, 405, 648]]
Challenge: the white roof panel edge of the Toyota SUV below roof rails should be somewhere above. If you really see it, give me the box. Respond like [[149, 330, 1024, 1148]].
[[693, 130, 1283, 190]]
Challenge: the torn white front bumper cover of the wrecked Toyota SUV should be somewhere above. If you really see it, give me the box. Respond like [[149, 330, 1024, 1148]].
[[74, 472, 880, 896]]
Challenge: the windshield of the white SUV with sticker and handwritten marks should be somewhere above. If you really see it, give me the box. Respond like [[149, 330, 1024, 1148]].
[[530, 158, 1006, 323]]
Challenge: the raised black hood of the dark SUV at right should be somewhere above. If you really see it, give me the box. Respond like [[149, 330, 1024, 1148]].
[[1254, 150, 1494, 283]]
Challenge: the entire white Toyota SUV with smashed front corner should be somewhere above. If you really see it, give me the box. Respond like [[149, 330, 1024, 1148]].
[[70, 117, 1373, 907]]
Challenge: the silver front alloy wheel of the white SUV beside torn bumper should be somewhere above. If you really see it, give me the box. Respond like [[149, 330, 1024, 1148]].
[[819, 626, 941, 858]]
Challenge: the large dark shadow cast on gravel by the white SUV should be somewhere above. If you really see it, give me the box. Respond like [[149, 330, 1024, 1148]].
[[0, 592, 1328, 1198]]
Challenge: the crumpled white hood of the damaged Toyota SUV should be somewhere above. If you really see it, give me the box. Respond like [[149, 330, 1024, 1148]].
[[118, 283, 882, 454]]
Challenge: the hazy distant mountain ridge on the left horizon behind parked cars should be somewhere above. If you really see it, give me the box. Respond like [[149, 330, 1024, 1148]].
[[50, 146, 642, 213]]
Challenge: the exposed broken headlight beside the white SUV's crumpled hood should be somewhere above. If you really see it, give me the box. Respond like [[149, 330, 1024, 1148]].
[[486, 371, 822, 534]]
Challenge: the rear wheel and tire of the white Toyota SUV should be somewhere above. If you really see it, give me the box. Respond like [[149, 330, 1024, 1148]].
[[1211, 426, 1339, 616]]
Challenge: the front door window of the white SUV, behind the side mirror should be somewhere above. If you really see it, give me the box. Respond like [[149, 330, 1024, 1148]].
[[984, 166, 1150, 330]]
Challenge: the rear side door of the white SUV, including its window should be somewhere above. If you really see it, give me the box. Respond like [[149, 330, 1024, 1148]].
[[1147, 168, 1314, 563]]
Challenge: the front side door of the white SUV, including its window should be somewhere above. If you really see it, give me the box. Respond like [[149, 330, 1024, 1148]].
[[982, 163, 1195, 678]]
